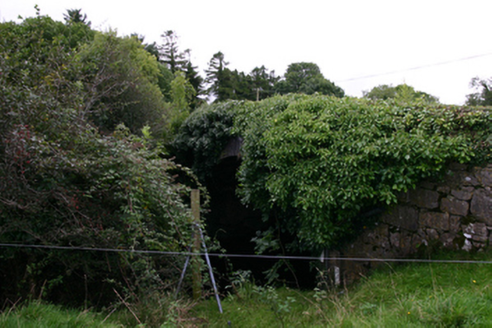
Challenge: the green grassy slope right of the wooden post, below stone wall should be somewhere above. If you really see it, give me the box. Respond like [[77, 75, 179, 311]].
[[190, 254, 492, 327]]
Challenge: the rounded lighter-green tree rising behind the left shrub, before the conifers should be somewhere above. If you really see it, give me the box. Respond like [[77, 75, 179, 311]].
[[78, 32, 166, 135]]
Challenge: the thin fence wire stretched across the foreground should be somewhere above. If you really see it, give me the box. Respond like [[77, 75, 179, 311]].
[[0, 244, 492, 264]]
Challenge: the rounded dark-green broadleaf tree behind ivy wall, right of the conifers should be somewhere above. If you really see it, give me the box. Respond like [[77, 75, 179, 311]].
[[275, 62, 345, 97]]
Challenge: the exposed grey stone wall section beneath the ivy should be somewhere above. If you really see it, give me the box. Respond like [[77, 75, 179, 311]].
[[331, 164, 492, 282]]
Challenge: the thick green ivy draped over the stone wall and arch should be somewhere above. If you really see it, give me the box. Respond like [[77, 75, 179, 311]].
[[176, 94, 492, 254]]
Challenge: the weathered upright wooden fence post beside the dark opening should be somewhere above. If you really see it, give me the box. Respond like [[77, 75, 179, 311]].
[[191, 189, 202, 300]]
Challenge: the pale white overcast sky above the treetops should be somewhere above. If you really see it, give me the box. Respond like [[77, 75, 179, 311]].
[[0, 0, 492, 104]]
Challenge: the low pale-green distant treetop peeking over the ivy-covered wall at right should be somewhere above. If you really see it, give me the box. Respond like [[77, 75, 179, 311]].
[[363, 83, 439, 104]]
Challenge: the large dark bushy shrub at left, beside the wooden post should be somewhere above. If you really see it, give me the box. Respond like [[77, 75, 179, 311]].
[[0, 16, 198, 305]]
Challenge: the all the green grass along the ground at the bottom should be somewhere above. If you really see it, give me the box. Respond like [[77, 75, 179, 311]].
[[0, 253, 492, 327]]
